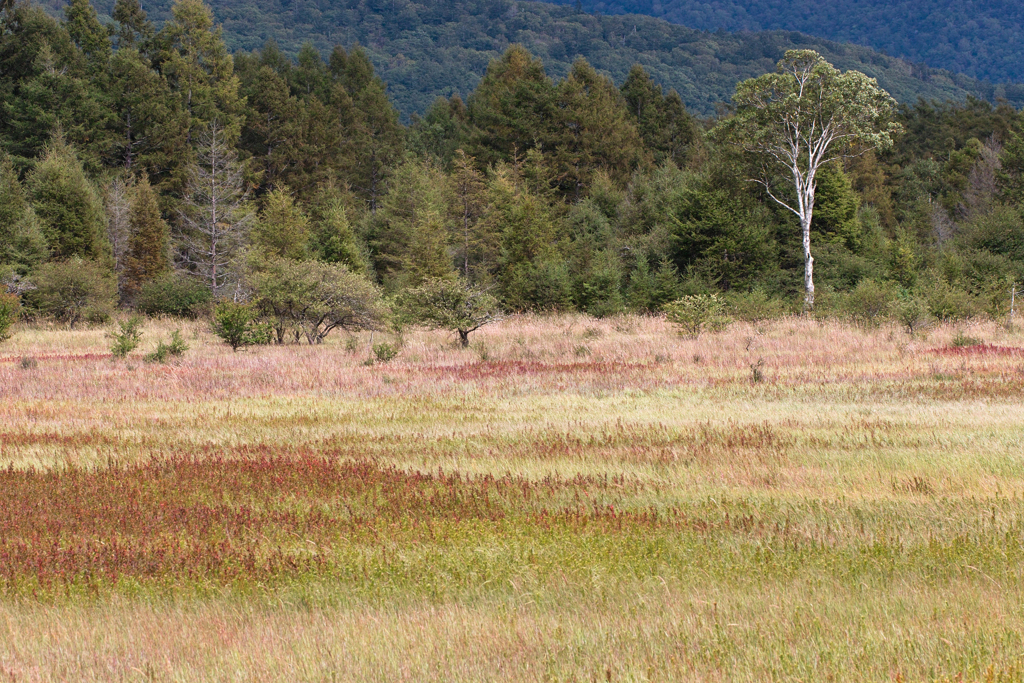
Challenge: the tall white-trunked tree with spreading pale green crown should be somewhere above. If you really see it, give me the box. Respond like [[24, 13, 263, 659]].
[[716, 50, 901, 309]]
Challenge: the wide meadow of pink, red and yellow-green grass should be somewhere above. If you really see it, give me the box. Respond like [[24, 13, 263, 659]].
[[0, 316, 1024, 682]]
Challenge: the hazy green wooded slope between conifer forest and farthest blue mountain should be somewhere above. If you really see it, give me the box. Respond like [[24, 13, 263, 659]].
[[37, 0, 1024, 116]]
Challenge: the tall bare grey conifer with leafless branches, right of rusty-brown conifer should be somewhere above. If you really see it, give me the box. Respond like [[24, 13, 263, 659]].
[[178, 122, 252, 296]]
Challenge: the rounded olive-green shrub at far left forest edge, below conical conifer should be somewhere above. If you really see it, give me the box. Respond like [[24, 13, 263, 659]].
[[26, 258, 118, 328]]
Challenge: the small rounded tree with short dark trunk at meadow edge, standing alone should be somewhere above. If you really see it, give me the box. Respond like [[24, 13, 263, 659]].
[[402, 278, 502, 347]]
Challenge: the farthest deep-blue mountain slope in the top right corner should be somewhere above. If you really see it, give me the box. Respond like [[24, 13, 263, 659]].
[[555, 0, 1024, 83]]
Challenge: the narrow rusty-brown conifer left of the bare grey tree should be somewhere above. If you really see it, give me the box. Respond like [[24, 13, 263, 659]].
[[121, 175, 170, 301]]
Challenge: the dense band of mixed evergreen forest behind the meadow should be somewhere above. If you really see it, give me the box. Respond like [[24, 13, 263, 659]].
[[0, 0, 1024, 344]]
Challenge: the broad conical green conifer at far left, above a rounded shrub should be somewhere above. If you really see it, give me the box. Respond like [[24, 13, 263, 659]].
[[28, 132, 111, 260]]
